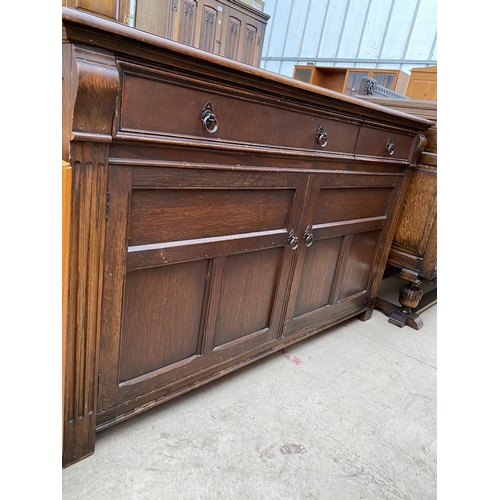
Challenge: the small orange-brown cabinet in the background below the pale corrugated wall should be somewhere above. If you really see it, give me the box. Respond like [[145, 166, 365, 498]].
[[293, 65, 409, 95]]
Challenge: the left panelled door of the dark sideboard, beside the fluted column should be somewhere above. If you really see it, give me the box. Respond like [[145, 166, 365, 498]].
[[94, 166, 307, 423]]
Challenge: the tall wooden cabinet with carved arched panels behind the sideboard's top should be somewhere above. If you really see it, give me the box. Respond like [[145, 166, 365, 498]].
[[63, 0, 269, 66]]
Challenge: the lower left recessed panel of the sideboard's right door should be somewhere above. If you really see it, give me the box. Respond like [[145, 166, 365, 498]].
[[294, 237, 342, 317]]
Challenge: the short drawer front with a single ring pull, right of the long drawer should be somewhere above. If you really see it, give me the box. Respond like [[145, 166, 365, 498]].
[[355, 125, 414, 160]]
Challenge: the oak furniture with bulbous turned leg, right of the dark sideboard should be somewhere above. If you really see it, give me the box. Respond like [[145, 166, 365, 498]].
[[359, 96, 437, 329]]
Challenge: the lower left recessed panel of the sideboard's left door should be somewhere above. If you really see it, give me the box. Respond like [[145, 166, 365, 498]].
[[119, 260, 208, 382]]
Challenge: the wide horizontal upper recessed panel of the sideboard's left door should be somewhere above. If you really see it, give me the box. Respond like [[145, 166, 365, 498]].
[[129, 189, 295, 245]]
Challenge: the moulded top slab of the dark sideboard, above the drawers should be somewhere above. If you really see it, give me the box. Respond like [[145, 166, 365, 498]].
[[62, 7, 432, 131]]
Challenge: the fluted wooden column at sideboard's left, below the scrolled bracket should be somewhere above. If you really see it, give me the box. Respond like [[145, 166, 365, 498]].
[[63, 143, 108, 465]]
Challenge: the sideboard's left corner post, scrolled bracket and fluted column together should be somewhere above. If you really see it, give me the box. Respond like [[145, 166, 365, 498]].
[[63, 39, 119, 465]]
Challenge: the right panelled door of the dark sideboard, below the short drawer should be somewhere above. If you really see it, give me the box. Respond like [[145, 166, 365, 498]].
[[284, 174, 402, 335]]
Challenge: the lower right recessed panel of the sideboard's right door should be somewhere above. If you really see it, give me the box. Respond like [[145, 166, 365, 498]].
[[338, 231, 381, 300]]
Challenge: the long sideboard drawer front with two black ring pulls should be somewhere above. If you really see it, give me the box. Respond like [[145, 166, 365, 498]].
[[118, 71, 359, 155]]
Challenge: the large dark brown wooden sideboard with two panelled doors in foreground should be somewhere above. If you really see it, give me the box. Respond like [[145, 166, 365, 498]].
[[63, 9, 430, 466]]
